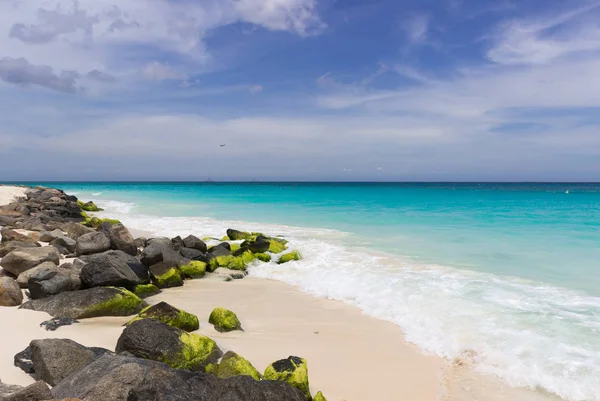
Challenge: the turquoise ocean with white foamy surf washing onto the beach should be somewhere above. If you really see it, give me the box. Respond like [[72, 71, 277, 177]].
[[22, 183, 600, 401]]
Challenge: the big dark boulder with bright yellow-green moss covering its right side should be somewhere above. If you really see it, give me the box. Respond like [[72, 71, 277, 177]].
[[116, 319, 223, 371]]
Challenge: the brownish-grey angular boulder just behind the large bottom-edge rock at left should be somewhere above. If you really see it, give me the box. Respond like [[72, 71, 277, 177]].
[[29, 338, 110, 386]]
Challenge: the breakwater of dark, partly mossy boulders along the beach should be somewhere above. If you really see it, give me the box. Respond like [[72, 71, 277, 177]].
[[0, 187, 325, 401]]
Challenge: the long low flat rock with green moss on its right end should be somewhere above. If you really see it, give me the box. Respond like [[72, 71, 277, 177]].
[[21, 287, 148, 319]]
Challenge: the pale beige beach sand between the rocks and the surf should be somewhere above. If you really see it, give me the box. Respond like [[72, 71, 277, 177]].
[[0, 187, 560, 401]]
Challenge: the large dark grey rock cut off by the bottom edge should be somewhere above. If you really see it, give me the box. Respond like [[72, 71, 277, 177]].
[[52, 355, 305, 401]]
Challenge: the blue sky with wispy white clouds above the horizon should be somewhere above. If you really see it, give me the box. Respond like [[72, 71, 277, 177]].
[[0, 0, 600, 181]]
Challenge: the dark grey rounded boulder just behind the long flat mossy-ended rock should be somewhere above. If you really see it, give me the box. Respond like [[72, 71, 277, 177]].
[[81, 251, 150, 288]]
